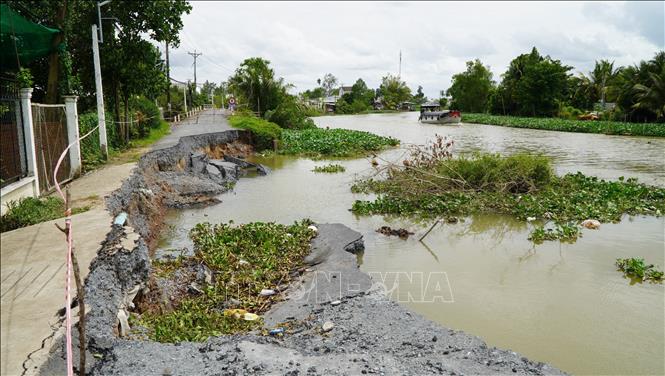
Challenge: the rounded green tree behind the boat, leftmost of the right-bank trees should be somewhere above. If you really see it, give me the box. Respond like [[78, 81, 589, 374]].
[[446, 59, 494, 112]]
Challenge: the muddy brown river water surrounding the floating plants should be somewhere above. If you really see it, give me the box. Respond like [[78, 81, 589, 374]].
[[161, 113, 665, 374]]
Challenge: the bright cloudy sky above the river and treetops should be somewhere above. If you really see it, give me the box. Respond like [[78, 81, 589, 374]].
[[162, 1, 665, 97]]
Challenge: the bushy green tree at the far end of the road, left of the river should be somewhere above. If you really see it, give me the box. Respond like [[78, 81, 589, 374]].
[[229, 57, 286, 117]]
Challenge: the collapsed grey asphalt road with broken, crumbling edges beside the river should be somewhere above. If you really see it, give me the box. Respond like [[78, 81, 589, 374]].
[[39, 131, 562, 375]]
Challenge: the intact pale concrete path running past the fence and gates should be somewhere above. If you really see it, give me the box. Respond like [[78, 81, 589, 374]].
[[0, 110, 230, 376]]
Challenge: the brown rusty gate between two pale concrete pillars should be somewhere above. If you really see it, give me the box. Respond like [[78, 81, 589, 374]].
[[32, 103, 71, 193]]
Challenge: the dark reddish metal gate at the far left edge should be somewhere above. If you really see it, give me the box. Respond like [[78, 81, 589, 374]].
[[0, 78, 28, 187]]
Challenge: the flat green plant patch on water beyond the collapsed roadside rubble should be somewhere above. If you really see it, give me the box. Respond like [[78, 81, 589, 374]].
[[279, 128, 399, 157]]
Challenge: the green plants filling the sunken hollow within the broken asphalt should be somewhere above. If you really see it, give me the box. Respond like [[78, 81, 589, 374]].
[[139, 220, 315, 342]]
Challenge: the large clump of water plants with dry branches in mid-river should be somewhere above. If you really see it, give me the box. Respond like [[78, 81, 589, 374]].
[[352, 141, 665, 242]]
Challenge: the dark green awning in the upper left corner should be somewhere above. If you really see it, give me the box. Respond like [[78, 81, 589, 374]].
[[0, 4, 60, 70]]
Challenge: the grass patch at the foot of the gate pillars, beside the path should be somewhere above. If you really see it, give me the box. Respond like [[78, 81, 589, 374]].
[[0, 196, 90, 232]]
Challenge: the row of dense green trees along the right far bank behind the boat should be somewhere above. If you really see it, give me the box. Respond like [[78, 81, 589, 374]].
[[446, 47, 665, 123]]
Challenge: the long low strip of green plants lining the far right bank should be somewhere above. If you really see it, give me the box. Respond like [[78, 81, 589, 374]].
[[462, 113, 665, 137]]
